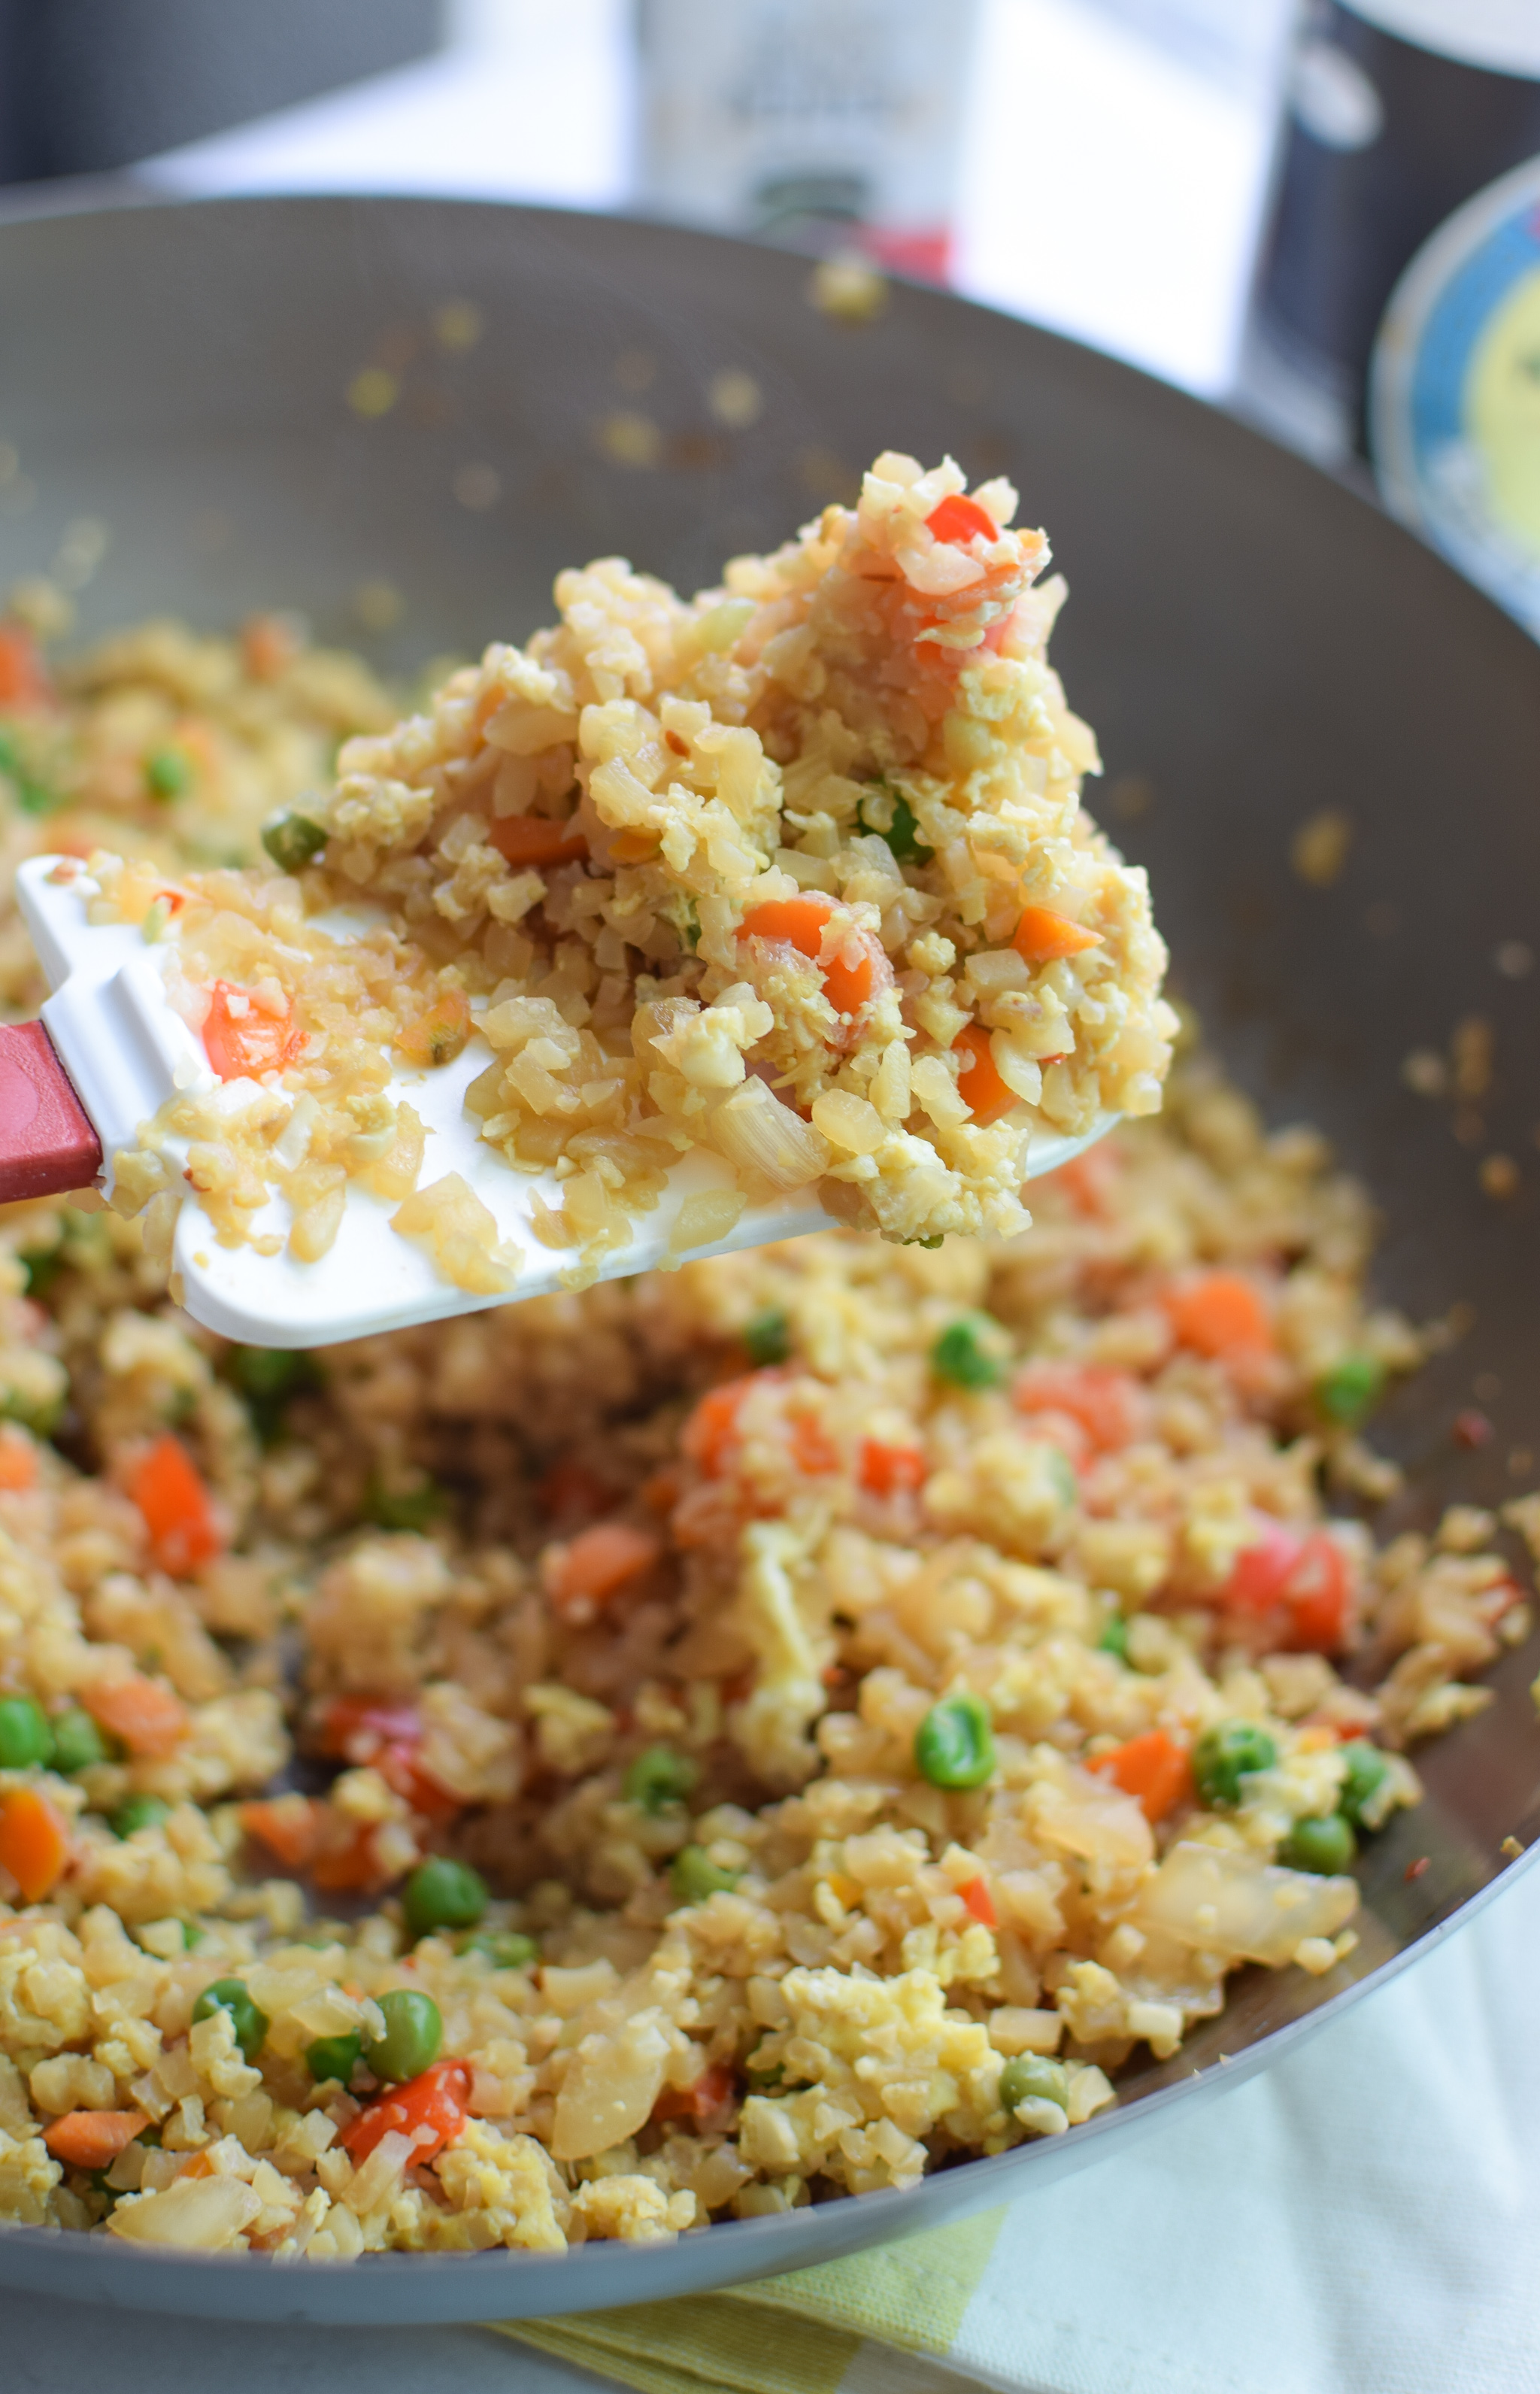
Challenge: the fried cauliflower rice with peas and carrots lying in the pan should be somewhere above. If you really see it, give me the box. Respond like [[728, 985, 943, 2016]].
[[0, 551, 1540, 2260]]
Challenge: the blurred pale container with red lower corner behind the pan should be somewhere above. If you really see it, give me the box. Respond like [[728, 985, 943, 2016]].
[[637, 0, 978, 283]]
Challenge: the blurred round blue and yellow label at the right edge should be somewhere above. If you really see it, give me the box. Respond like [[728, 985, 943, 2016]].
[[1370, 158, 1540, 637]]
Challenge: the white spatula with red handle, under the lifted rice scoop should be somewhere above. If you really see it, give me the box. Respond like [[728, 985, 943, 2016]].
[[0, 857, 1111, 1348]]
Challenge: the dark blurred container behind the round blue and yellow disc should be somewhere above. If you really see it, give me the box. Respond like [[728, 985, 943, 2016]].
[[1235, 0, 1540, 467]]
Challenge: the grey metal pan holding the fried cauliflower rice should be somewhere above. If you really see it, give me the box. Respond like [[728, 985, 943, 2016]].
[[0, 196, 1540, 2325]]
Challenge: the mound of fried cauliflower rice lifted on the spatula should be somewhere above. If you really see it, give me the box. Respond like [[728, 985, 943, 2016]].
[[62, 455, 1176, 1295]]
